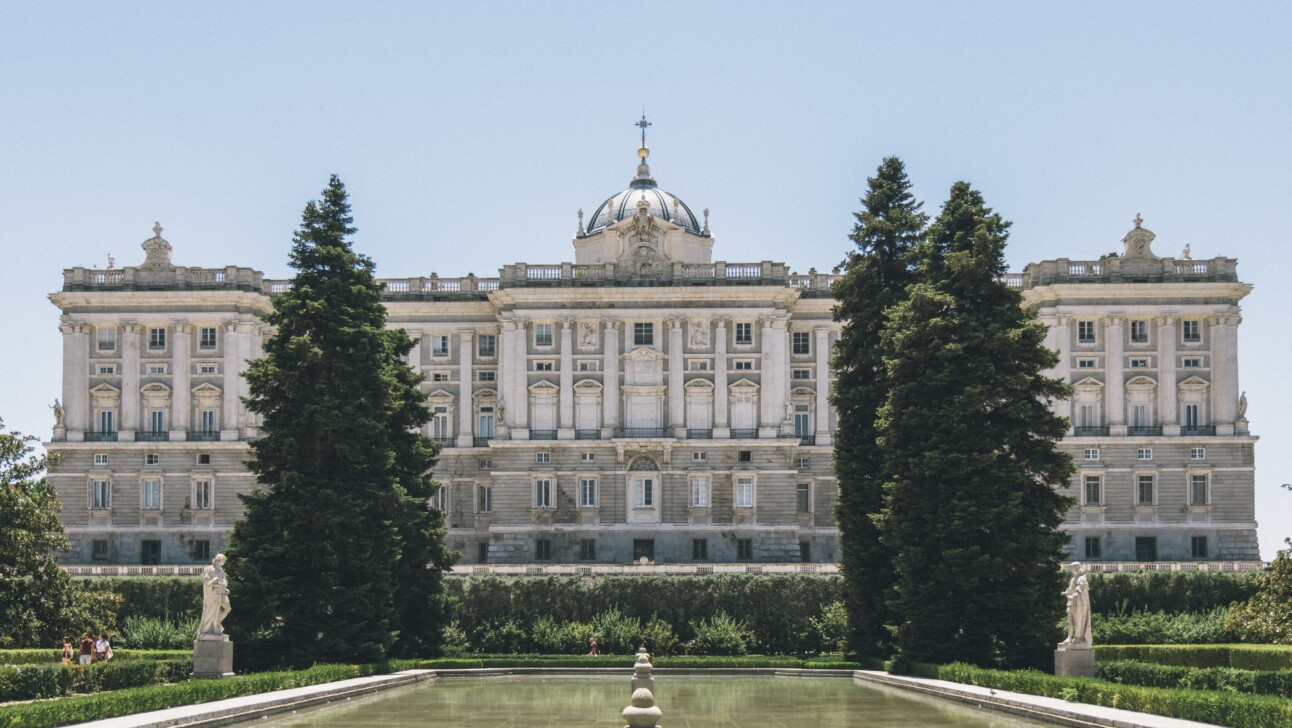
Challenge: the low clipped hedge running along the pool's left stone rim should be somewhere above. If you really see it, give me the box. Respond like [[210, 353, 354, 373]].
[[0, 665, 377, 728]]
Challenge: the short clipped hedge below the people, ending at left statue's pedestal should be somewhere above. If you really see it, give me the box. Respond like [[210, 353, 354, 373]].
[[0, 658, 193, 702]]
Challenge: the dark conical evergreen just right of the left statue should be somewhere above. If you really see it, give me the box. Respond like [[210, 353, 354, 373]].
[[229, 176, 451, 665]]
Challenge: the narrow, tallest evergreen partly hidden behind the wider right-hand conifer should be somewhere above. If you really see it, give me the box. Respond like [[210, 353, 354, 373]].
[[831, 156, 928, 657]]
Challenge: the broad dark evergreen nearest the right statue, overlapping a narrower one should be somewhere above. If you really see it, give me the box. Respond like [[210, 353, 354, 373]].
[[879, 182, 1074, 667]]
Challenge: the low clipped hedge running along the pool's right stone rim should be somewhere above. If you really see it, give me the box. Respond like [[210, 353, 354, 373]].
[[911, 662, 1292, 728]]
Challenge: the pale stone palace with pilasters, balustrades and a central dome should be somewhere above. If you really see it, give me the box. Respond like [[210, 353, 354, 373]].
[[48, 140, 1257, 564]]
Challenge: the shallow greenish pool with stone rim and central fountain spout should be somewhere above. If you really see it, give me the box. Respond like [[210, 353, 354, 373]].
[[243, 674, 1047, 728]]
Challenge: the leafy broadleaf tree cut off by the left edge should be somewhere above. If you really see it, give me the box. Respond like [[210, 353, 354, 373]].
[[0, 420, 120, 647]]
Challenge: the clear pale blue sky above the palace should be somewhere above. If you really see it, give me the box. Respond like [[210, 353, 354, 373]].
[[0, 0, 1292, 559]]
